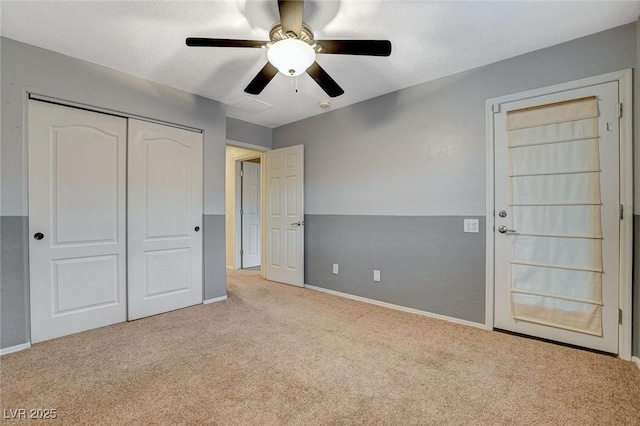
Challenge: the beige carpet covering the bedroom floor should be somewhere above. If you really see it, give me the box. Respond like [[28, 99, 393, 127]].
[[0, 272, 640, 425]]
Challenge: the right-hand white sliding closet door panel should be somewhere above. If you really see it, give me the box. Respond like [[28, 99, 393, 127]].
[[128, 119, 203, 320]]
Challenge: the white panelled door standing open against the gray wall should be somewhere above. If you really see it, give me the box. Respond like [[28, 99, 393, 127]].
[[265, 145, 304, 286]]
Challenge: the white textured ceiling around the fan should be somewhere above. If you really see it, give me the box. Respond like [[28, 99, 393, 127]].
[[0, 0, 640, 127]]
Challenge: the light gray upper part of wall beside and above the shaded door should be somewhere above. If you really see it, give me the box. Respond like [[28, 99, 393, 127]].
[[273, 23, 637, 216]]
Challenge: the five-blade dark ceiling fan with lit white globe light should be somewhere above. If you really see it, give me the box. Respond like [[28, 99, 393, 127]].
[[186, 0, 391, 98]]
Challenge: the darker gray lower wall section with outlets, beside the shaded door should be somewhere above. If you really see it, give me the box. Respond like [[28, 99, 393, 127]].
[[305, 215, 485, 323]]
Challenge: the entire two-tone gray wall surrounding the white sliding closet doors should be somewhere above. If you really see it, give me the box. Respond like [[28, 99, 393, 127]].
[[0, 38, 226, 348]]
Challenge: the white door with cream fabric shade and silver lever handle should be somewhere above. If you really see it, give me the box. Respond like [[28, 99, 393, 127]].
[[494, 82, 620, 353]]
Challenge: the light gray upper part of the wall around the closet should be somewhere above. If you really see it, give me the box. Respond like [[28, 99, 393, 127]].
[[0, 37, 226, 216]]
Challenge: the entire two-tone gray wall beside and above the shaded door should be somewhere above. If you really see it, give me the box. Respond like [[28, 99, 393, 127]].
[[273, 23, 638, 332]]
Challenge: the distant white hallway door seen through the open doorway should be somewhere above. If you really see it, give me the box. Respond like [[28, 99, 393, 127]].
[[240, 161, 261, 268]]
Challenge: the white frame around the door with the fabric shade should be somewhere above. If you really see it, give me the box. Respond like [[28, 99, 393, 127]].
[[485, 69, 633, 361]]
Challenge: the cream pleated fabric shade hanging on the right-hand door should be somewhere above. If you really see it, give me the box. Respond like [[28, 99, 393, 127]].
[[507, 97, 603, 336]]
